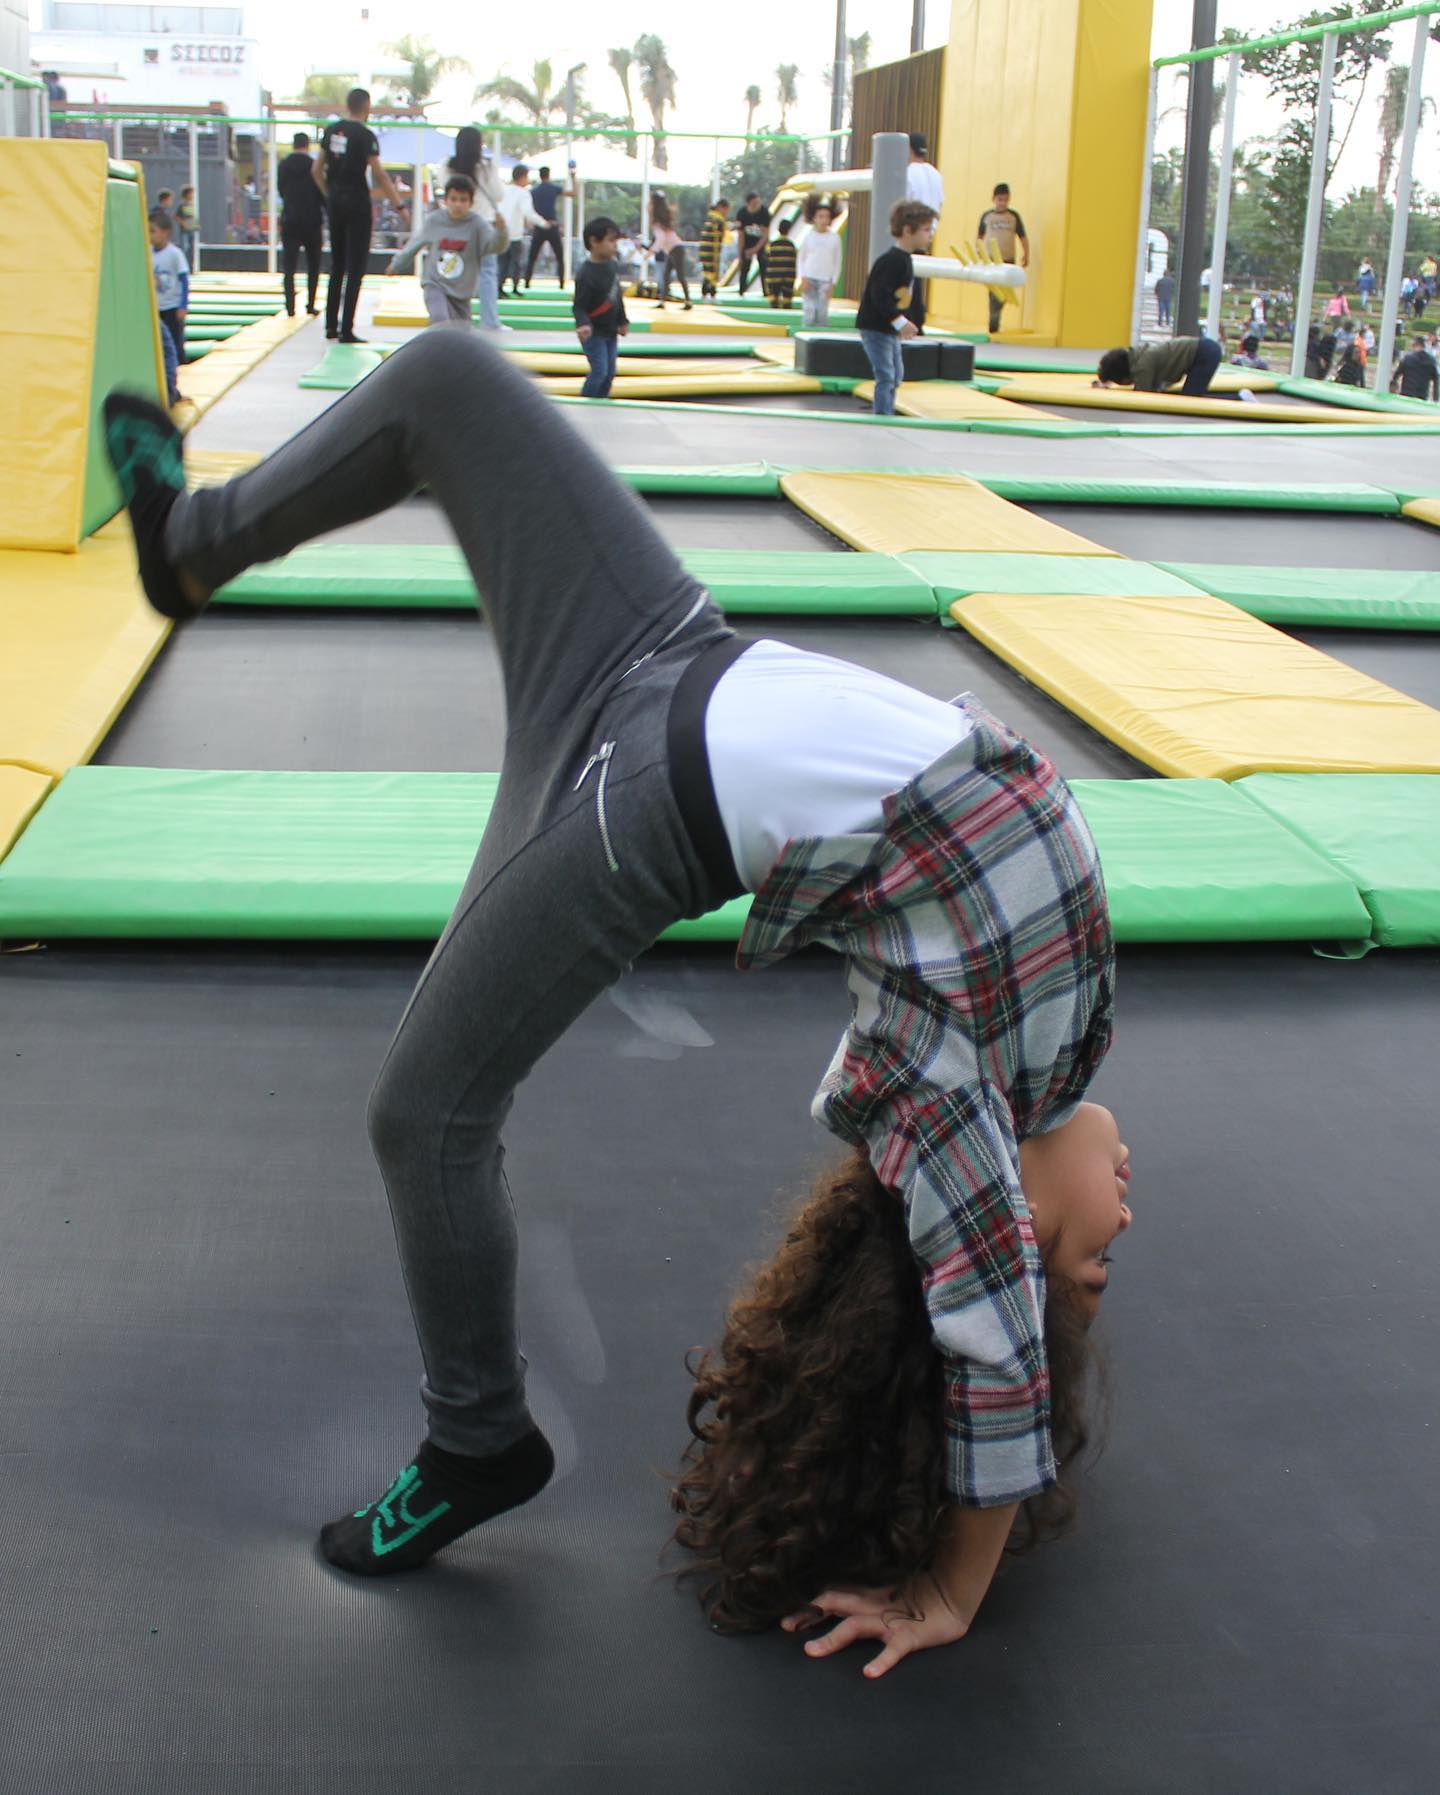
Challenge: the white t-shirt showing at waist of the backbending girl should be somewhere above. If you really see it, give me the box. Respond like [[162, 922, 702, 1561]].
[[706, 641, 971, 890]]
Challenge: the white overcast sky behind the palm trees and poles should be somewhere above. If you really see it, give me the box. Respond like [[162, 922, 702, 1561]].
[[32, 0, 1440, 194]]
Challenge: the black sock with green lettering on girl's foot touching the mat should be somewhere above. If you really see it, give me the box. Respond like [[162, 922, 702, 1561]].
[[320, 1427, 555, 1576]]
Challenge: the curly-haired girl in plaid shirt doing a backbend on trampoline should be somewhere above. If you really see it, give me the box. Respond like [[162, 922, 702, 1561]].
[[106, 330, 1129, 1675]]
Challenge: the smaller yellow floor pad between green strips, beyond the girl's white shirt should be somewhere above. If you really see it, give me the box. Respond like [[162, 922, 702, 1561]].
[[779, 472, 1115, 555]]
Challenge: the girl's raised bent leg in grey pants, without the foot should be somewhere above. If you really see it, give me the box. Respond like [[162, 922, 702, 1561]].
[[165, 333, 706, 729]]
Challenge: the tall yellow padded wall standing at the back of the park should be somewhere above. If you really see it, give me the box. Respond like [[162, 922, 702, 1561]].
[[930, 0, 1151, 345]]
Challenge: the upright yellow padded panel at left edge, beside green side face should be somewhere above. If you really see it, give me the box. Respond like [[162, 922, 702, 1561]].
[[0, 136, 110, 551]]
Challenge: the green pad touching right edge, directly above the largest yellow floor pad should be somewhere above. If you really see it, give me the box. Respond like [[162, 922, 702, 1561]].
[[1160, 562, 1440, 630]]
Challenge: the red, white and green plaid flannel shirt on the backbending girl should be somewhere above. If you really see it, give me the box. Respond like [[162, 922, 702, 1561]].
[[736, 693, 1113, 1506]]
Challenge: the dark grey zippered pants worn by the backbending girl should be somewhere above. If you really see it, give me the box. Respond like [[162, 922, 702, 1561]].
[[167, 330, 729, 1454]]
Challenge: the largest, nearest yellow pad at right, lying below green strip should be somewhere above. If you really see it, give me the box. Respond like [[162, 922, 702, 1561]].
[[950, 592, 1440, 779]]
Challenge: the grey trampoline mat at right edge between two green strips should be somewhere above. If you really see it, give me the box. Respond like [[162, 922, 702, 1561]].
[[1025, 504, 1438, 569]]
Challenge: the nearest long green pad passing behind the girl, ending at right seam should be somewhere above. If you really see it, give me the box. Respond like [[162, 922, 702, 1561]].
[[0, 766, 1371, 941]]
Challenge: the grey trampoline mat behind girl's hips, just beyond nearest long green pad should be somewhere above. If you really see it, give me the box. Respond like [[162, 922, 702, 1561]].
[[95, 609, 1149, 779]]
